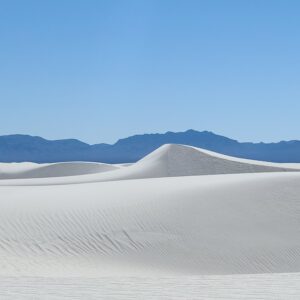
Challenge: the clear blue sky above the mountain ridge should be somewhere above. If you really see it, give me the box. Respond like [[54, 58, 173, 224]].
[[0, 0, 300, 143]]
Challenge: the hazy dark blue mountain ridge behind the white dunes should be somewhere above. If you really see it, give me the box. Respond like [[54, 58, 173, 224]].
[[0, 129, 300, 163]]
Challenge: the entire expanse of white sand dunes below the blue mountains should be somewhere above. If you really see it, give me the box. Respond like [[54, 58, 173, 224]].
[[0, 145, 300, 299]]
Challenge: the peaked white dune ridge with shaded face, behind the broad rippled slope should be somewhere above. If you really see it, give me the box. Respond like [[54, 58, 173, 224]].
[[0, 144, 300, 185]]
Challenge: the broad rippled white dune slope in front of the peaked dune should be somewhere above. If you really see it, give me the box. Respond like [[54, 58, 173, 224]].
[[0, 173, 300, 276]]
